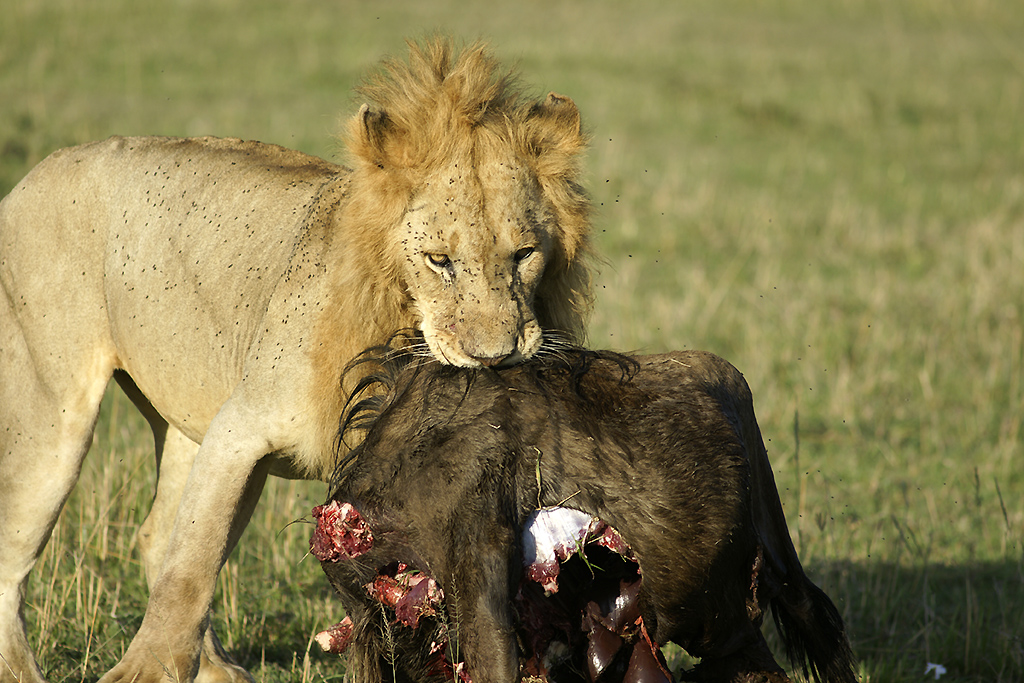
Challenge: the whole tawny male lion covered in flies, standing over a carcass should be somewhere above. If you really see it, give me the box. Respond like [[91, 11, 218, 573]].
[[0, 38, 591, 683]]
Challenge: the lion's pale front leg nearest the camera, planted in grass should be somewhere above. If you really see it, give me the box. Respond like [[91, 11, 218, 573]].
[[100, 411, 269, 683]]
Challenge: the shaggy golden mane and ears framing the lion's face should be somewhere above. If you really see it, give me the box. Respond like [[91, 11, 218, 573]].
[[342, 38, 592, 343]]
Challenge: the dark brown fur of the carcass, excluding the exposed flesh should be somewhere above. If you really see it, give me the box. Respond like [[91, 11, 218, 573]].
[[324, 350, 856, 683]]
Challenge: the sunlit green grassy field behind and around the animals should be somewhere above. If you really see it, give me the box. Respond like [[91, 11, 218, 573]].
[[0, 0, 1024, 683]]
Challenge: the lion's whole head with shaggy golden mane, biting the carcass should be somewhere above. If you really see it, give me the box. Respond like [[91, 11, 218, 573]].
[[347, 39, 590, 367]]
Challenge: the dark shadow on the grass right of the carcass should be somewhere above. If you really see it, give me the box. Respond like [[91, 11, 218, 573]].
[[765, 557, 1024, 683]]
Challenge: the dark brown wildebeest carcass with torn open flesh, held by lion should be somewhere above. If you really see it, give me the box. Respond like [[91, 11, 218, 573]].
[[311, 350, 856, 683]]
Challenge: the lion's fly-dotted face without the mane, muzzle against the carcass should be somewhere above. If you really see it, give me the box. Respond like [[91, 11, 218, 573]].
[[400, 158, 551, 368]]
